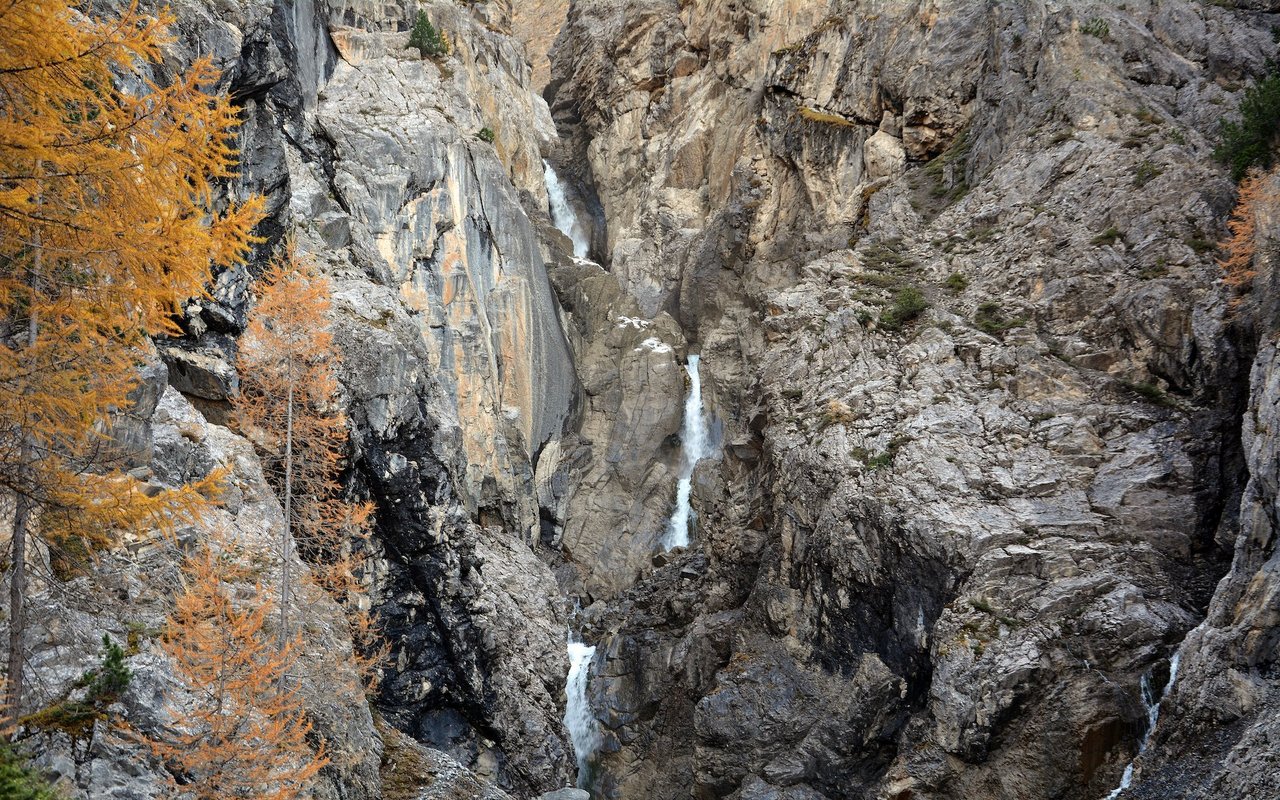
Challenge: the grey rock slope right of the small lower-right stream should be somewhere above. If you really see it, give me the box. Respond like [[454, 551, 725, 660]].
[[1126, 175, 1280, 797]]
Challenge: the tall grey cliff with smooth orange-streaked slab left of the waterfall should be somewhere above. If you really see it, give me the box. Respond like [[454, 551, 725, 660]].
[[23, 0, 577, 797]]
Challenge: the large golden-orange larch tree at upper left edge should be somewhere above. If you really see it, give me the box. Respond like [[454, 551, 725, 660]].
[[0, 0, 261, 714]]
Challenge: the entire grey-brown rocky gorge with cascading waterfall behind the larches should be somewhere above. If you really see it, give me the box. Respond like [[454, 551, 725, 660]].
[[7, 0, 1280, 800]]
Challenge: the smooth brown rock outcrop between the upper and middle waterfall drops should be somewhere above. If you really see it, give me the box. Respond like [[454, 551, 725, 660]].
[[536, 221, 686, 596]]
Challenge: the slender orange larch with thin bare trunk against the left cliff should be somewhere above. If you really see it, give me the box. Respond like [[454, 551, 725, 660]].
[[233, 251, 376, 680]]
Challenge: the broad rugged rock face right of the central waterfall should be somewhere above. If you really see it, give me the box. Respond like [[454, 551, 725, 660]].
[[549, 1, 1275, 797]]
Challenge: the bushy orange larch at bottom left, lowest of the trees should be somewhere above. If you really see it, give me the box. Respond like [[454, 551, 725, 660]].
[[150, 536, 328, 800]]
